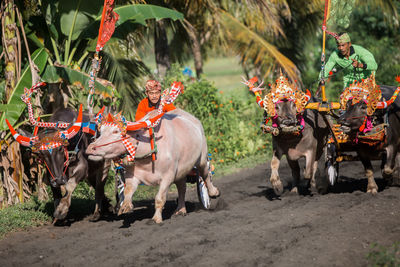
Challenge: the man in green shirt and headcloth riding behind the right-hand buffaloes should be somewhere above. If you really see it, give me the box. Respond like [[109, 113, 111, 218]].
[[320, 33, 378, 89]]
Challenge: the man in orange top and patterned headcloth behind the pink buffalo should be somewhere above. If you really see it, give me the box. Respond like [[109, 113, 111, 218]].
[[135, 80, 176, 121]]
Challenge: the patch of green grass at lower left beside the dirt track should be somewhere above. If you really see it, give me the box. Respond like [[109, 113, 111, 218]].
[[0, 197, 51, 238]]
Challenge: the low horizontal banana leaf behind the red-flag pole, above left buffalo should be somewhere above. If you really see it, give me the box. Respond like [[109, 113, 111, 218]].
[[42, 65, 118, 96]]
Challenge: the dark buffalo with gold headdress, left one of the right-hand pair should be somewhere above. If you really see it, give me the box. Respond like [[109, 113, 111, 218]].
[[244, 74, 329, 195]]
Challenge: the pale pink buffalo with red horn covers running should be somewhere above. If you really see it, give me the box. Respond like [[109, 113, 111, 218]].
[[86, 109, 219, 223]]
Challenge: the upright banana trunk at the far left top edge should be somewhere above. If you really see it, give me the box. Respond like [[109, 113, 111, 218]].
[[1, 0, 18, 102]]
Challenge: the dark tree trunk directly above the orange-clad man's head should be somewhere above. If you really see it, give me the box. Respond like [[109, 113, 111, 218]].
[[154, 20, 171, 78]]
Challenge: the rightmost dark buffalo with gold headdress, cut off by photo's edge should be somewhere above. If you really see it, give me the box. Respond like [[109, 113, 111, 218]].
[[339, 80, 400, 194]]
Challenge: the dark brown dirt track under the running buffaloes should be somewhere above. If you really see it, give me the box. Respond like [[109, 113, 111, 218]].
[[0, 160, 400, 266]]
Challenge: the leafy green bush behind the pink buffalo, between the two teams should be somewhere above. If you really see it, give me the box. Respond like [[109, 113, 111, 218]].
[[165, 65, 270, 163]]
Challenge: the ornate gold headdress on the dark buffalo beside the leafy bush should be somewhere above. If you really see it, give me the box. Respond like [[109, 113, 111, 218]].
[[264, 74, 310, 117]]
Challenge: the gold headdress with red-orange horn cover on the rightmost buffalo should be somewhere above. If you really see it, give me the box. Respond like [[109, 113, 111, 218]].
[[340, 74, 400, 116]]
